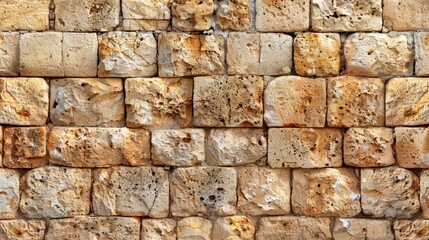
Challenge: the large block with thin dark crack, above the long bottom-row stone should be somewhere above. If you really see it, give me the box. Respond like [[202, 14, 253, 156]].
[[92, 167, 169, 218]]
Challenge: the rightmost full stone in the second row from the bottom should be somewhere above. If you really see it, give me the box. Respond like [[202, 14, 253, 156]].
[[361, 167, 420, 218]]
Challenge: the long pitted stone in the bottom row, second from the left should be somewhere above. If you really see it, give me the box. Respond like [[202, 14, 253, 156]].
[[46, 216, 140, 240]]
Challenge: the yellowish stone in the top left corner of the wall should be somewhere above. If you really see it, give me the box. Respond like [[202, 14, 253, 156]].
[[0, 0, 51, 31]]
